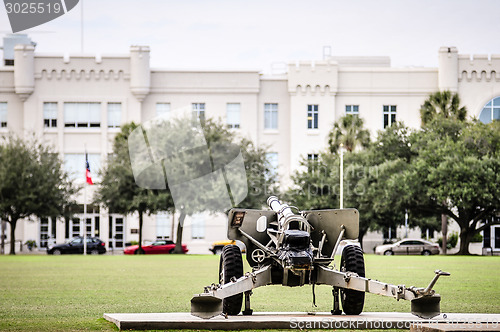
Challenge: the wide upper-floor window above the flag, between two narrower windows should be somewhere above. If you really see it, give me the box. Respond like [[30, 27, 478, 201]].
[[64, 103, 101, 128]]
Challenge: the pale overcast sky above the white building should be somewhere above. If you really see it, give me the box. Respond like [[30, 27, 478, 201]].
[[0, 0, 500, 72]]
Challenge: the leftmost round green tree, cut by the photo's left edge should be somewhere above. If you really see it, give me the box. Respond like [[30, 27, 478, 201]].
[[0, 135, 77, 255]]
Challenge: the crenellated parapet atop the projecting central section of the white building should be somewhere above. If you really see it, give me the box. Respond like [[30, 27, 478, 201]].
[[288, 60, 338, 96]]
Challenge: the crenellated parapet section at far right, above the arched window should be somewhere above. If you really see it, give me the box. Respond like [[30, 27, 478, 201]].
[[458, 55, 500, 82]]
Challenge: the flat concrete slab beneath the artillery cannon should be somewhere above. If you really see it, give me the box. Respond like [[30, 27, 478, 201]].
[[104, 312, 500, 332]]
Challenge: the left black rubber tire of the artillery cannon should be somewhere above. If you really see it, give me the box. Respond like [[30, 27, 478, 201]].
[[219, 244, 243, 315]]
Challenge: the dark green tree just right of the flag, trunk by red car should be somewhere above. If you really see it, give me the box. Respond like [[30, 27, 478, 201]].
[[94, 122, 174, 254]]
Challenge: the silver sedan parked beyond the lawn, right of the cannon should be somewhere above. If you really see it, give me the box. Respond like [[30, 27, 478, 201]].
[[375, 239, 439, 256]]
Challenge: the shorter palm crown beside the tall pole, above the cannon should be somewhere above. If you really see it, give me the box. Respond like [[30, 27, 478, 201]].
[[328, 114, 370, 153]]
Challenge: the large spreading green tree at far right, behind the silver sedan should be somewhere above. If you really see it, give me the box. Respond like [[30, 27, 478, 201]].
[[387, 119, 500, 255]]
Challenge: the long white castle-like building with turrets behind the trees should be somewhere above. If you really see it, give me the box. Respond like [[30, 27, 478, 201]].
[[0, 37, 500, 253]]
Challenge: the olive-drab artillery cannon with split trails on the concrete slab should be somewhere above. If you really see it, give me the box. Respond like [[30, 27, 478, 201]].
[[191, 196, 450, 318]]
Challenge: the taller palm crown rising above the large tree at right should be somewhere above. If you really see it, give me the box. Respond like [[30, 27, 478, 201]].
[[420, 90, 467, 126]]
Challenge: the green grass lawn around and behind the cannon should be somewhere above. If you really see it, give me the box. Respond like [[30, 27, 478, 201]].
[[0, 255, 500, 331]]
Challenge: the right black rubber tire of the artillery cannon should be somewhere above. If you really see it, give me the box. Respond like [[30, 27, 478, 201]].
[[340, 245, 365, 315]]
